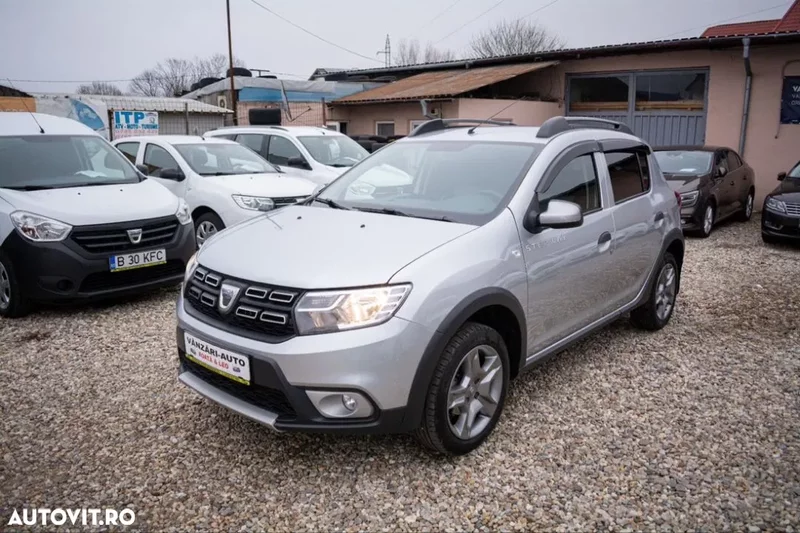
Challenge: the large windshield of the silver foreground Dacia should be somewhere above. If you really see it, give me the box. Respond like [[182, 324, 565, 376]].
[[313, 141, 541, 225]]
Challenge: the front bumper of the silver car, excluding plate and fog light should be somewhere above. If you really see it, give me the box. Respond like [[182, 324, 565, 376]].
[[177, 298, 435, 433]]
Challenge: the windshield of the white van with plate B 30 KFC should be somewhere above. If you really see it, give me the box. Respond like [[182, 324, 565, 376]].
[[0, 135, 140, 190]]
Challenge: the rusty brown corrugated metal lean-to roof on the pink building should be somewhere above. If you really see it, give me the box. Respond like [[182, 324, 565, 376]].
[[334, 61, 557, 104]]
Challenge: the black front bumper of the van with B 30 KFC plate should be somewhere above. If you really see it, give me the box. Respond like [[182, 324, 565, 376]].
[[2, 224, 196, 302]]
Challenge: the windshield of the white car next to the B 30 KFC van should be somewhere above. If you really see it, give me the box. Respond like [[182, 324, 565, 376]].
[[173, 142, 277, 176]]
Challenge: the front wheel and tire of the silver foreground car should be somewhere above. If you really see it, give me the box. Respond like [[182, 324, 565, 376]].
[[415, 322, 510, 455]]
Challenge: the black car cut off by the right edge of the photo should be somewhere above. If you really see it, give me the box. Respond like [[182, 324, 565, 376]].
[[761, 162, 800, 243]]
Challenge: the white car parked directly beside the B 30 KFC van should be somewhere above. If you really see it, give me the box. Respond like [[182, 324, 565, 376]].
[[113, 135, 315, 246]]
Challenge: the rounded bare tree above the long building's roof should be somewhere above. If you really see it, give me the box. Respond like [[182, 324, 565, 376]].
[[470, 19, 564, 57]]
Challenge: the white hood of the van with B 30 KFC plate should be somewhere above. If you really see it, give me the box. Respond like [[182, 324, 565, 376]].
[[0, 179, 179, 226]]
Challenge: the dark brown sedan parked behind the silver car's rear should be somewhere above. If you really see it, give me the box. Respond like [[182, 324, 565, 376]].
[[655, 146, 755, 237]]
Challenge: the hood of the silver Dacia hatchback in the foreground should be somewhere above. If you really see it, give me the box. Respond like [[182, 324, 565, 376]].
[[197, 206, 477, 289]]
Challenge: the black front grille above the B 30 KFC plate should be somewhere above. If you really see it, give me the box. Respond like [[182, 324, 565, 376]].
[[70, 217, 179, 254]]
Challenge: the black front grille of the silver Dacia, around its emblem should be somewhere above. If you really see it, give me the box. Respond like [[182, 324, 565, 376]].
[[184, 267, 301, 342]]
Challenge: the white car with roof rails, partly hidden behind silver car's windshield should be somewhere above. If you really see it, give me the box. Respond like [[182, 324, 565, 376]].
[[203, 126, 369, 185]]
